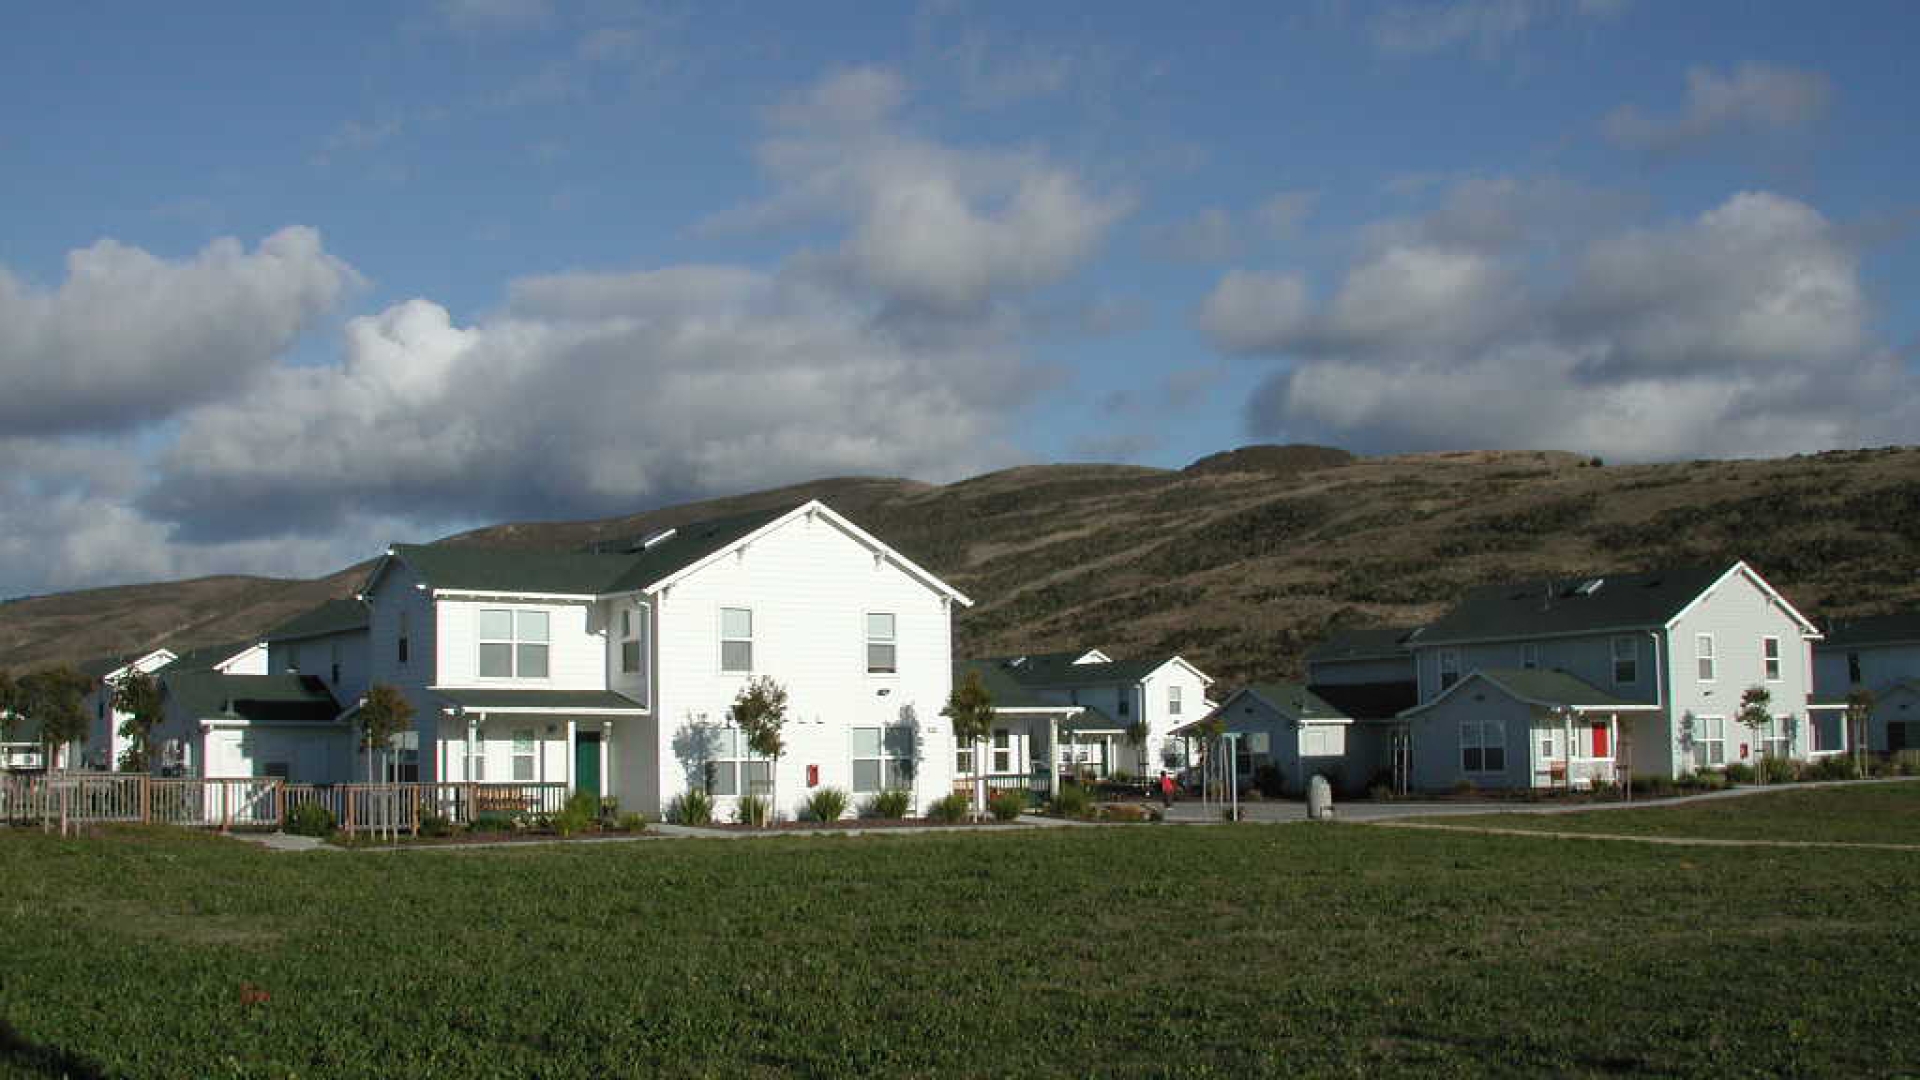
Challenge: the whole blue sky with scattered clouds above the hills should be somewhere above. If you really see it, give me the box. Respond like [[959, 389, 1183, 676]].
[[0, 0, 1920, 596]]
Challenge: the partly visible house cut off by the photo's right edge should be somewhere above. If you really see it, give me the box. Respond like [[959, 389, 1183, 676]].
[[1812, 611, 1920, 753]]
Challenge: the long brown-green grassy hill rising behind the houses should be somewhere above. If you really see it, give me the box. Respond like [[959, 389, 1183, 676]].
[[0, 446, 1920, 682]]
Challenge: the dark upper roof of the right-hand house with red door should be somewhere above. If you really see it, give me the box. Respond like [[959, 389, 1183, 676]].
[[1407, 567, 1726, 648]]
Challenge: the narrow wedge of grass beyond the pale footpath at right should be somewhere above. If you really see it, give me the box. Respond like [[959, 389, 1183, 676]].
[[1425, 780, 1920, 844]]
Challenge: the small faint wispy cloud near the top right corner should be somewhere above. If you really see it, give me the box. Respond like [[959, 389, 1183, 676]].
[[1605, 63, 1832, 154]]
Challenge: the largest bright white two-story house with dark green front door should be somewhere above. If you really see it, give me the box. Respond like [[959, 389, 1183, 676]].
[[361, 502, 970, 817]]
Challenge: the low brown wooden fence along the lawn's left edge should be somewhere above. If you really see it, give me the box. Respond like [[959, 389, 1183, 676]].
[[0, 773, 566, 836]]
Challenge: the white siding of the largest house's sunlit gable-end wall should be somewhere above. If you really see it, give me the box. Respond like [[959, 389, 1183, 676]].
[[656, 515, 954, 817]]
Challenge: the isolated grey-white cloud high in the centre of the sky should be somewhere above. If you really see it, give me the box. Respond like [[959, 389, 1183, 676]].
[[708, 67, 1131, 315]]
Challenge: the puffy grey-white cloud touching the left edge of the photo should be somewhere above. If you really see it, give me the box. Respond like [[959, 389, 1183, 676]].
[[0, 227, 359, 434]]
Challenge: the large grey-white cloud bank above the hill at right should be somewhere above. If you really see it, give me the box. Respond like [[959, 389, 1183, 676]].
[[1200, 183, 1920, 459]]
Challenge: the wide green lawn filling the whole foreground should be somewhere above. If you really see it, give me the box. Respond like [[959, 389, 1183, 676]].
[[0, 824, 1920, 1080]]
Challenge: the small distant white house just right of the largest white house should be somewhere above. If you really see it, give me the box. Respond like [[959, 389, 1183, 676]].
[[954, 650, 1213, 788]]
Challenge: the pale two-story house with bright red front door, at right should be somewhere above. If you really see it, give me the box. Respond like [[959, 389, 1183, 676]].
[[1402, 563, 1845, 790]]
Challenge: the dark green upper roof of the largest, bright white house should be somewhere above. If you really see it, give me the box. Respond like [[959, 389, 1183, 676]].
[[394, 505, 795, 596]]
